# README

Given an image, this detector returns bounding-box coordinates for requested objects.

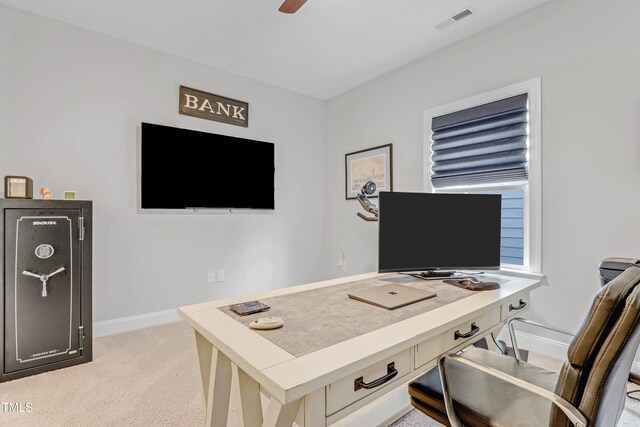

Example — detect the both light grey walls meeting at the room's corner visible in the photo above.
[0,0,640,338]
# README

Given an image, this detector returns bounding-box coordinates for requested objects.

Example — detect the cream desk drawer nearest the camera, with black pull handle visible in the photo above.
[326,349,411,416]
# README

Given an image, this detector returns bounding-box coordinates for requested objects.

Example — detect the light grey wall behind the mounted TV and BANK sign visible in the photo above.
[0,6,326,321]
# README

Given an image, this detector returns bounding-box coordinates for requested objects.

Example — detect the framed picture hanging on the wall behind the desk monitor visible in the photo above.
[344,144,393,200]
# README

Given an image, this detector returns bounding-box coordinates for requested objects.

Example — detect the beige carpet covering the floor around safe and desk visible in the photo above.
[0,322,640,427]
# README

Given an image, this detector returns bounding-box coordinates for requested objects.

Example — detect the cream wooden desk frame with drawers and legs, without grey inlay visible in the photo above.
[178,273,540,427]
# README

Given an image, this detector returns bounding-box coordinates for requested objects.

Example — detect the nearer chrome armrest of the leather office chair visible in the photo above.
[438,354,587,427]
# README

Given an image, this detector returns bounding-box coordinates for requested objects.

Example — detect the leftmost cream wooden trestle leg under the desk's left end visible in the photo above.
[195,332,232,427]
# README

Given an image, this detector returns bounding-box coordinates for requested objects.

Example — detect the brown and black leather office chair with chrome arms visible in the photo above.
[409,267,640,427]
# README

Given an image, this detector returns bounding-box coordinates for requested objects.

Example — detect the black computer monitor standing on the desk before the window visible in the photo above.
[378,192,502,272]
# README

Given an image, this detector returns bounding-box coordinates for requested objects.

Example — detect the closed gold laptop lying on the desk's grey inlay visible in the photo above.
[348,283,436,310]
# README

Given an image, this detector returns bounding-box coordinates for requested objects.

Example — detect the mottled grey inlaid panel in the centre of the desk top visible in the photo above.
[219,274,511,357]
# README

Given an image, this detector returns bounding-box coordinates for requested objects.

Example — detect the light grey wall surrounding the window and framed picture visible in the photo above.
[326,0,640,330]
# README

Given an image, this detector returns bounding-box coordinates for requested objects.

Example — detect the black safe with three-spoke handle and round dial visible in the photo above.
[0,200,92,382]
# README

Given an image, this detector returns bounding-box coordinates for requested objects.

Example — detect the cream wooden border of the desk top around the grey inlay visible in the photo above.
[178,273,541,401]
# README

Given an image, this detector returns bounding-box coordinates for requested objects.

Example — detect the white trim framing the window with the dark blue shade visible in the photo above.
[422,78,542,273]
